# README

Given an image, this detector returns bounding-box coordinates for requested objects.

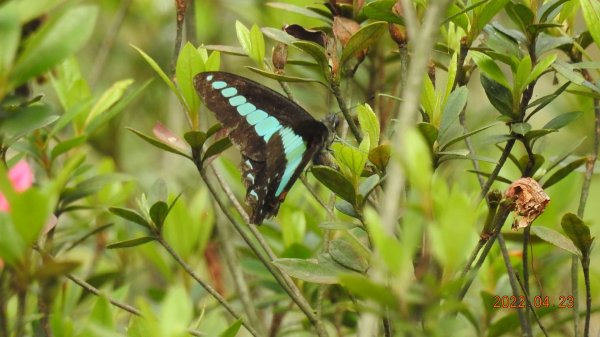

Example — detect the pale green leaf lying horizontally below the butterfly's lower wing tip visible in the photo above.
[273,255,347,284]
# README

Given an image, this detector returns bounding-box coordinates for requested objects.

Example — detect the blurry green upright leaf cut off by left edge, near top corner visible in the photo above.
[0,9,21,80]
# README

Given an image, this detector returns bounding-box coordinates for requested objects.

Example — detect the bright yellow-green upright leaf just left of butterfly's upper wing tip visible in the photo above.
[175,42,205,113]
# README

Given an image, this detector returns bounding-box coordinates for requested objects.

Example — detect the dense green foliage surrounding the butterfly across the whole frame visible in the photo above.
[0,0,600,336]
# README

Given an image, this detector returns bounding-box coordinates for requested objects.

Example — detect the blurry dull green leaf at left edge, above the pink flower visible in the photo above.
[0,104,59,146]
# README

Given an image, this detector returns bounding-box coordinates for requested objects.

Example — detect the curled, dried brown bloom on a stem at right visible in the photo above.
[504,178,550,230]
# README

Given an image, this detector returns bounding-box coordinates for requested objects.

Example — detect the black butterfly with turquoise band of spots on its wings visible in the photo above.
[194,71,329,225]
